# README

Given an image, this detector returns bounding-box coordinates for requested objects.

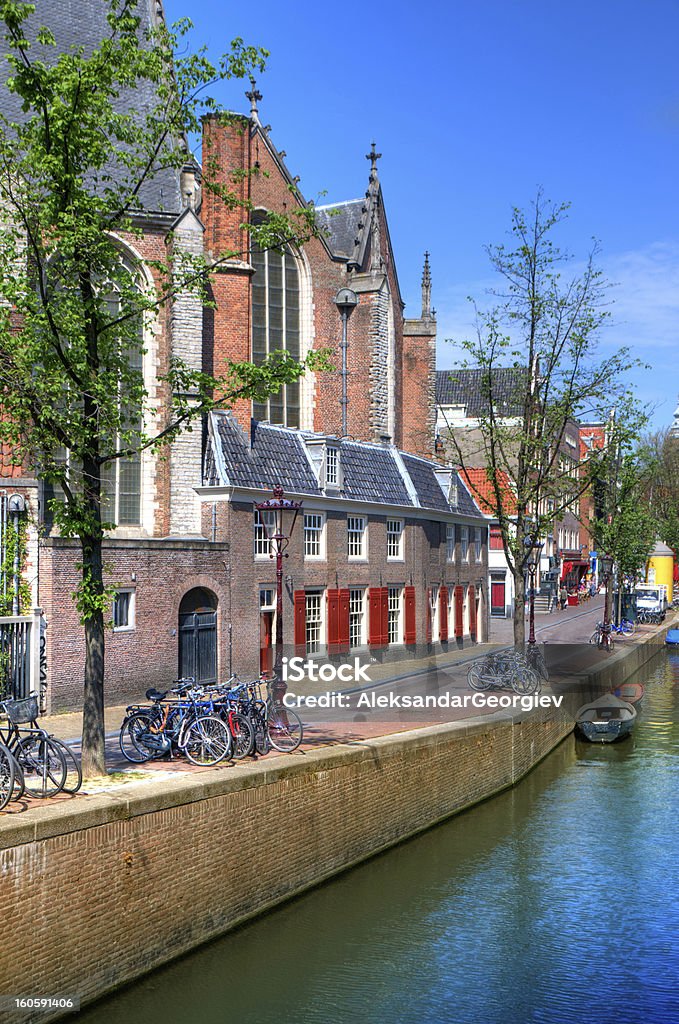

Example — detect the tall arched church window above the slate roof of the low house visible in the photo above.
[251,214,301,427]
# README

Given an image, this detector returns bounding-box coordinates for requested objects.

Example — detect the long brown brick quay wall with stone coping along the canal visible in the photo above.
[0,626,661,1022]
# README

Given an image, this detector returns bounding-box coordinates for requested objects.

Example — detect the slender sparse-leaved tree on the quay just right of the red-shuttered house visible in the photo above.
[451,190,634,644]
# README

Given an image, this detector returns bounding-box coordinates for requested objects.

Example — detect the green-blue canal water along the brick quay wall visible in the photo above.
[79,653,679,1024]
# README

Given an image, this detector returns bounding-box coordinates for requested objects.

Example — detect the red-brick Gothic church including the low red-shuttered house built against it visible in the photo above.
[0,0,489,711]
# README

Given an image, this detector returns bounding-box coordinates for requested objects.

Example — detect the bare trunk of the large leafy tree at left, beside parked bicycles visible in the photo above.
[82,538,107,778]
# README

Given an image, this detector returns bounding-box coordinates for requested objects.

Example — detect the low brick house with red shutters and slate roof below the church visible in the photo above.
[201,413,489,674]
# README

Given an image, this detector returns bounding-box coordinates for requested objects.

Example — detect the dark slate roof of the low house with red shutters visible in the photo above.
[204,413,480,518]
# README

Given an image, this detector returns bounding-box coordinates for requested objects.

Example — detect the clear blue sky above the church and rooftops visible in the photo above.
[165,0,679,427]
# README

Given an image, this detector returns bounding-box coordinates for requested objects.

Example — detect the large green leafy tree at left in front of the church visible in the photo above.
[0,0,323,775]
